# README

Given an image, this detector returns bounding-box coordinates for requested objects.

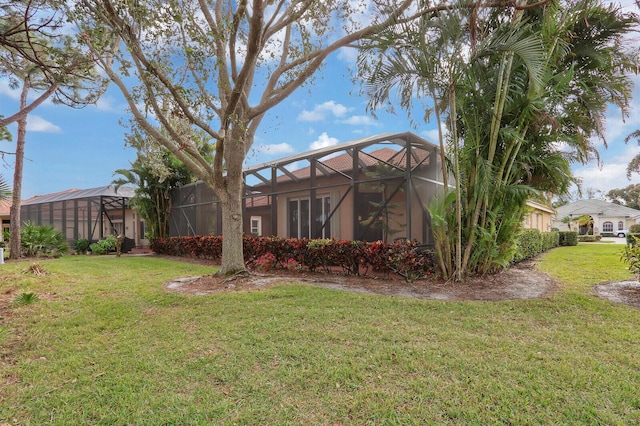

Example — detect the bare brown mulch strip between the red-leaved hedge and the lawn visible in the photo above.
[165,259,556,301]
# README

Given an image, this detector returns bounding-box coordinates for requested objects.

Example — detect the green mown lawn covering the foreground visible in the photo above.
[0,245,640,425]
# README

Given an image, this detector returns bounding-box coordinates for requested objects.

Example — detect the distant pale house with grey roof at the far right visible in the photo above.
[553,199,640,235]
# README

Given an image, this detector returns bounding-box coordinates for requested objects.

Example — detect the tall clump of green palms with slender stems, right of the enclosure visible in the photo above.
[361,0,634,279]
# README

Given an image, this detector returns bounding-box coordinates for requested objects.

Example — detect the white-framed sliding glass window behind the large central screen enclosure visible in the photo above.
[288,196,331,238]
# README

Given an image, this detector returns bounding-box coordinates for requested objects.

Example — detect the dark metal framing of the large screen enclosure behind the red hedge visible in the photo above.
[171,132,444,244]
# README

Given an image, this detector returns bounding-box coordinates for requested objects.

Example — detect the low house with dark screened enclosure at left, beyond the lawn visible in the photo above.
[20,186,147,248]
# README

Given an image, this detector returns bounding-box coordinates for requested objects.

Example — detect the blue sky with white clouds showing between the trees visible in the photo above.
[0,0,640,199]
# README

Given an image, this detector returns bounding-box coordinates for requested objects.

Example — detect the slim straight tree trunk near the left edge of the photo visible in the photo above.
[9,80,29,259]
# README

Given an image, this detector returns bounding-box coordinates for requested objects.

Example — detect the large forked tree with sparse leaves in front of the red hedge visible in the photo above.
[67,0,417,274]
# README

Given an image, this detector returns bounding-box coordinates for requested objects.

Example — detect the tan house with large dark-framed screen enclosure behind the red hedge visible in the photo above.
[170,133,444,244]
